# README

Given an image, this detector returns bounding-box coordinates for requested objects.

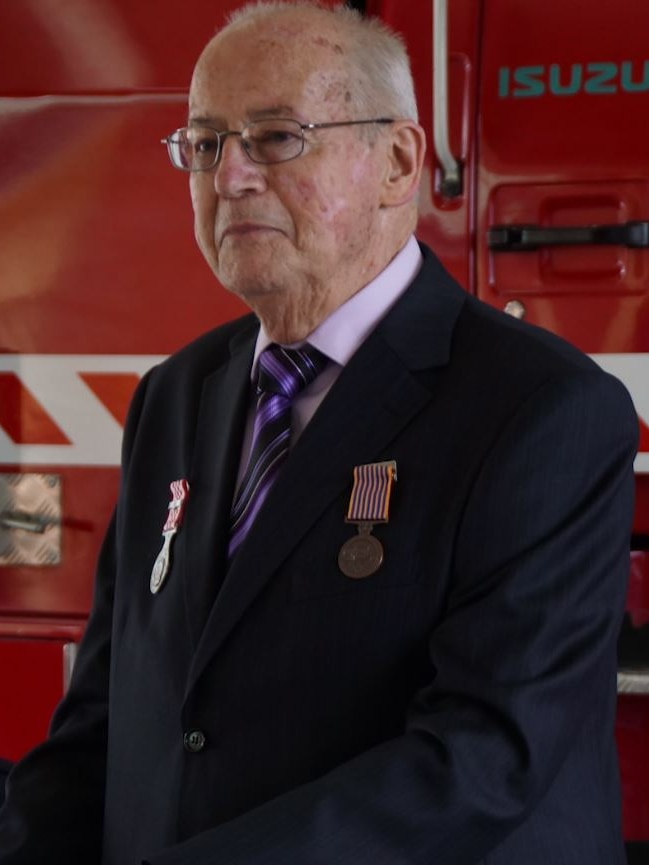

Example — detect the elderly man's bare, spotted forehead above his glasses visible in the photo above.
[190,15,352,120]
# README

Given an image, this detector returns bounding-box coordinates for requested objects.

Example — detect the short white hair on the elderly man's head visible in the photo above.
[219,0,418,121]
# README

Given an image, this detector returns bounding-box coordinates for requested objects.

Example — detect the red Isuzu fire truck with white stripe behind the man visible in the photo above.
[0,0,649,861]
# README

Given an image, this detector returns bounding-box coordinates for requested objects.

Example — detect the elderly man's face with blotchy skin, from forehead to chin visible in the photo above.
[189,15,385,335]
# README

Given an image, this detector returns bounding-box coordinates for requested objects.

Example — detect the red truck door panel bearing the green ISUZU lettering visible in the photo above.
[478,0,649,352]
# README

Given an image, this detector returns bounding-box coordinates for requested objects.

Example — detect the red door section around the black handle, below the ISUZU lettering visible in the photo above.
[481,178,649,353]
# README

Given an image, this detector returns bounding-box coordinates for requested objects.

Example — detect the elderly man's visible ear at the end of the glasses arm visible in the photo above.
[381,120,426,207]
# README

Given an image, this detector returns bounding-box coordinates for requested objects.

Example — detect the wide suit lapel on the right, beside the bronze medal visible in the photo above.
[188,245,466,690]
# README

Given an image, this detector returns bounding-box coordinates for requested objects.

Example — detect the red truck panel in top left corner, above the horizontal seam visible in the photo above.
[0,0,344,96]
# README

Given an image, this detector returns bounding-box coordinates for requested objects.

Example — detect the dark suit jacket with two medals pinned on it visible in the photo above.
[0,245,637,865]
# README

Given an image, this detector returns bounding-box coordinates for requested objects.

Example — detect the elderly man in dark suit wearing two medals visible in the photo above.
[0,3,637,865]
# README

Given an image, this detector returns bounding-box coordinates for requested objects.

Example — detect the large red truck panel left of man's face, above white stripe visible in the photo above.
[0,97,243,354]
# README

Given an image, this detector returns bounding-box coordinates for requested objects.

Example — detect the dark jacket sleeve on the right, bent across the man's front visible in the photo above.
[147,368,638,865]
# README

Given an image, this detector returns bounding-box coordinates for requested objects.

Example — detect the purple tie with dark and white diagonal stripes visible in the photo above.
[228,345,328,558]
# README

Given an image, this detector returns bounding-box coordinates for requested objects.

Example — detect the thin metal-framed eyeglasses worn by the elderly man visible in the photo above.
[161,117,394,171]
